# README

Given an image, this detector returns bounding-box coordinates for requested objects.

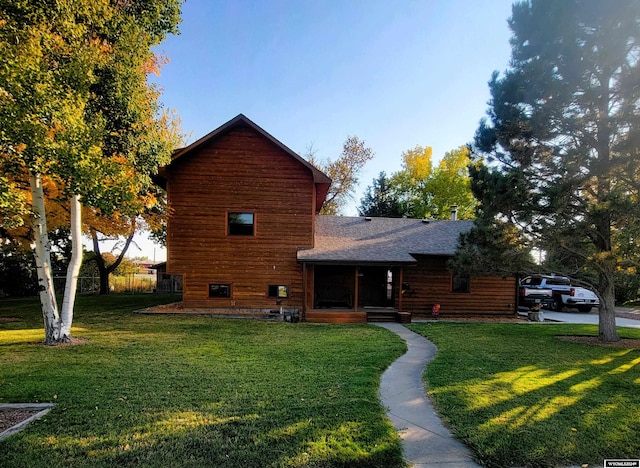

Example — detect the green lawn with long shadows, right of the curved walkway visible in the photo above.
[410,323,640,467]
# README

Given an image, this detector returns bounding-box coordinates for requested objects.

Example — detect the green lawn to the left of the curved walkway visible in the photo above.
[0,294,405,468]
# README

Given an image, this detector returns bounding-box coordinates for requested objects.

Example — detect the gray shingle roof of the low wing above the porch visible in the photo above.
[298,216,473,263]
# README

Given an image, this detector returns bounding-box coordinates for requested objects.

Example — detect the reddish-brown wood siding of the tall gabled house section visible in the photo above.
[167,122,315,310]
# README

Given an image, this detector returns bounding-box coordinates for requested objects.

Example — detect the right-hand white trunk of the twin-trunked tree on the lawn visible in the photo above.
[59,195,82,341]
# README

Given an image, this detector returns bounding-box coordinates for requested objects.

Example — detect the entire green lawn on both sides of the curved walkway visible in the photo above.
[6,294,640,468]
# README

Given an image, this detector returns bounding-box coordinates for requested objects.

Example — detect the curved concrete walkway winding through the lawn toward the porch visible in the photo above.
[376,323,480,468]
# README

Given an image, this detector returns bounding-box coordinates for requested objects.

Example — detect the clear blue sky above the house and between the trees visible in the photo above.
[136,0,512,255]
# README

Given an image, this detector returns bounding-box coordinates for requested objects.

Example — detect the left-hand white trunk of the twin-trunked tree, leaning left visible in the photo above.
[29,172,60,344]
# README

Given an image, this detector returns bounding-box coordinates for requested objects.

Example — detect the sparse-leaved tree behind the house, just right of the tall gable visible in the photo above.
[306,136,374,215]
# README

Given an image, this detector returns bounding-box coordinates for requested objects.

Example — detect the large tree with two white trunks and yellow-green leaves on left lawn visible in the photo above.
[0,0,181,344]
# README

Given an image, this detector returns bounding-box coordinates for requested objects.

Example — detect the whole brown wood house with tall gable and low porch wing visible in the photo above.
[156,115,516,322]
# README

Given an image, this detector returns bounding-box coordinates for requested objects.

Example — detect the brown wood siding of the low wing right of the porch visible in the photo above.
[402,256,516,319]
